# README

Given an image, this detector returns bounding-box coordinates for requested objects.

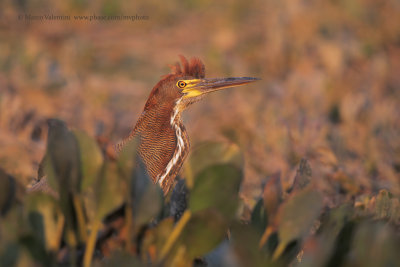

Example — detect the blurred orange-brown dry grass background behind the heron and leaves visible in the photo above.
[0,0,400,201]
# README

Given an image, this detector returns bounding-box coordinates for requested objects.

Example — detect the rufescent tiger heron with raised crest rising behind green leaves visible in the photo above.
[116,56,259,194]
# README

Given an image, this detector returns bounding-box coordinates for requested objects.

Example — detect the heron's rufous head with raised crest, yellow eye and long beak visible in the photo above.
[145,56,259,112]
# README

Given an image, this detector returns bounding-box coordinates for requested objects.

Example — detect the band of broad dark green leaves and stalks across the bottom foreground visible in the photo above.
[0,120,400,266]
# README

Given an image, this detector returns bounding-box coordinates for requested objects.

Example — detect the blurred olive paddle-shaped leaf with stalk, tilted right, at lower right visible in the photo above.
[273,188,323,259]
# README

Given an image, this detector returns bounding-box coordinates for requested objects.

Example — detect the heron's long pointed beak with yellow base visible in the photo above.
[178,77,260,98]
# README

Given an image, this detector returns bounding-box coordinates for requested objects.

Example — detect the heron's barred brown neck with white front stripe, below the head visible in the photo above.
[117,103,190,192]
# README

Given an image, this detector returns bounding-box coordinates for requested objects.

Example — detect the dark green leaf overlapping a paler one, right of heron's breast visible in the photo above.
[189,164,243,220]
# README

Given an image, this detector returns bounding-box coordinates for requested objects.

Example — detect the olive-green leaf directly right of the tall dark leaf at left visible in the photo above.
[72,130,103,191]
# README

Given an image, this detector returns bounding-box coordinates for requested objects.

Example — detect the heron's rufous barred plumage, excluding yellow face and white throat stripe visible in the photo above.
[116,55,205,193]
